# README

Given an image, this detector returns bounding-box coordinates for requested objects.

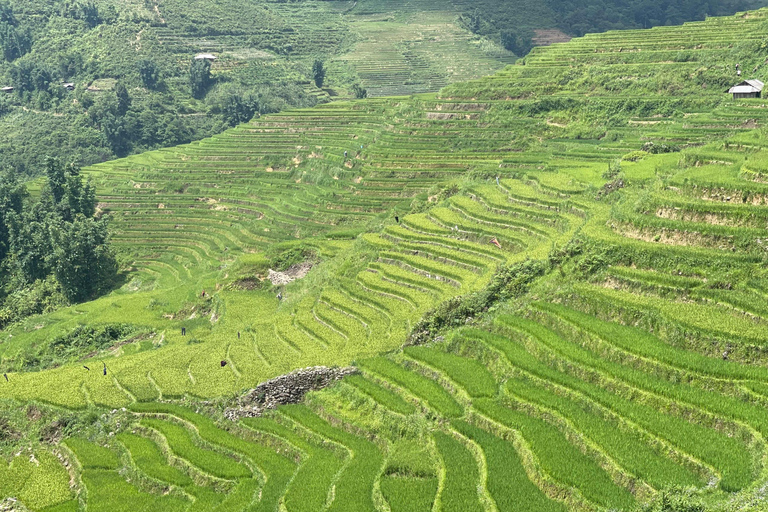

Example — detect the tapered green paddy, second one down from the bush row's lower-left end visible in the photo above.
[359,357,463,417]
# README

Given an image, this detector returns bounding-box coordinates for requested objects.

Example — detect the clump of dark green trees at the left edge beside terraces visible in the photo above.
[0,158,117,327]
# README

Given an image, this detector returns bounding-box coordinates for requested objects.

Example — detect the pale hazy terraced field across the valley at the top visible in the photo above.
[144,0,516,99]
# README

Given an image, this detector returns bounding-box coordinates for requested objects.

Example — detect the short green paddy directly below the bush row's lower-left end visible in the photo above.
[404,347,497,398]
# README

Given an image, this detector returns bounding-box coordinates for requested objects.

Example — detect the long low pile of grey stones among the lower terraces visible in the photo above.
[224,366,358,421]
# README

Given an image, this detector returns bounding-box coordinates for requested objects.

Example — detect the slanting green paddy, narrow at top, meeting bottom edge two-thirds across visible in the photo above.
[451,420,566,512]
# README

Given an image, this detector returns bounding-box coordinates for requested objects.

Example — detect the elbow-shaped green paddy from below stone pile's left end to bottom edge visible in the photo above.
[242,418,344,512]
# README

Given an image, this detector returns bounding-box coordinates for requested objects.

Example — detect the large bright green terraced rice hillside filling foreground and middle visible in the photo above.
[6,11,768,512]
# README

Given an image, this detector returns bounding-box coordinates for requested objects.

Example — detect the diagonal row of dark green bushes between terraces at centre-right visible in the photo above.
[408,260,550,345]
